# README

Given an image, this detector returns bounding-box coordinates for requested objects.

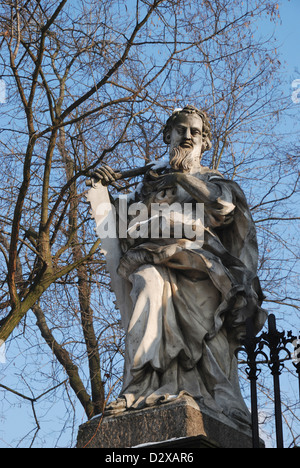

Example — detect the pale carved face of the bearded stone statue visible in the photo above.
[170,113,203,155]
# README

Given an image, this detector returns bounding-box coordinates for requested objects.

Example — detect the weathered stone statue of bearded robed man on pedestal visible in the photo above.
[88,106,266,425]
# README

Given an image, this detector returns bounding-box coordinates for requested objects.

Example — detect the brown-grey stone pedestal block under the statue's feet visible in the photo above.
[77,397,258,448]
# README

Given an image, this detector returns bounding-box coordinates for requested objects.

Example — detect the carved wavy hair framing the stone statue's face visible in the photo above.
[163,106,212,153]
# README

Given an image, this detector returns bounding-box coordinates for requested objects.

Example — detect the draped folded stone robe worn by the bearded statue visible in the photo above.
[88,167,266,424]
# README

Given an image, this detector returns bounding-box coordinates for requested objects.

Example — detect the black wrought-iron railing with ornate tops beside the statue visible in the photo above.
[238,314,300,448]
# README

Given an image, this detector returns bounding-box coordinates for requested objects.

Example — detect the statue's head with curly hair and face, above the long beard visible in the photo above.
[163,106,212,159]
